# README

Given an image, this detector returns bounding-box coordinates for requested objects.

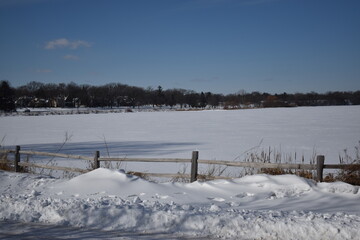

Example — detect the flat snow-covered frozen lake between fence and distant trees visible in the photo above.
[0,106,360,173]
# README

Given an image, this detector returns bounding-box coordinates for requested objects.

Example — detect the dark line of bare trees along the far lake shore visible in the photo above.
[0,81,360,111]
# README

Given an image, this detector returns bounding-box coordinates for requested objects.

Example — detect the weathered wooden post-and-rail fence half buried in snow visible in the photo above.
[0,146,360,182]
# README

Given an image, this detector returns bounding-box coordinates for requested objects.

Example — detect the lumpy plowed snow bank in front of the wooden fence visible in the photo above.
[0,169,360,239]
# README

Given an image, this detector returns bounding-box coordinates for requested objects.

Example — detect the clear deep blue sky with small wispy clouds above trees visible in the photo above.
[0,0,360,94]
